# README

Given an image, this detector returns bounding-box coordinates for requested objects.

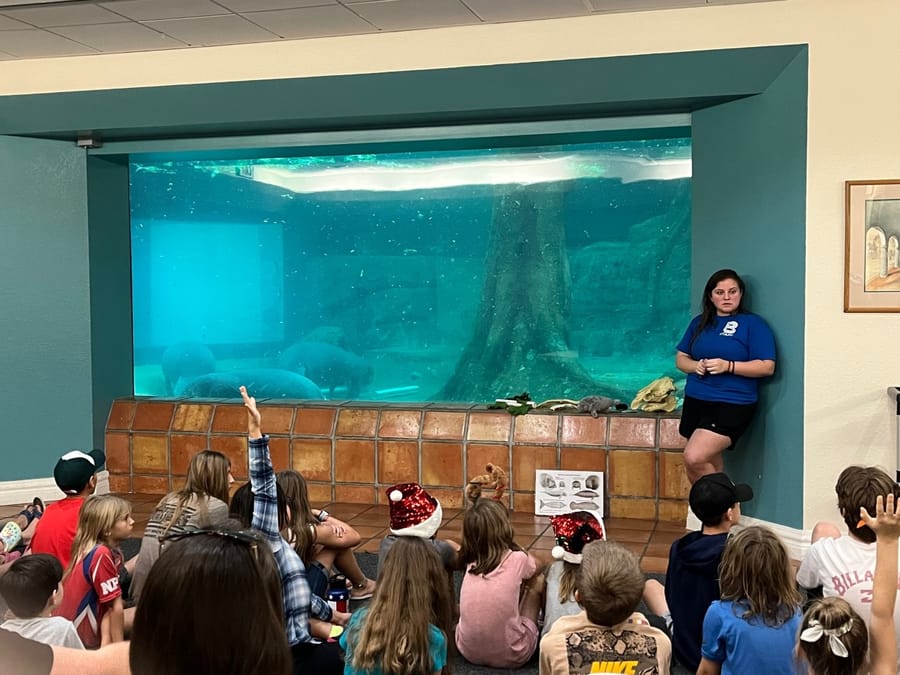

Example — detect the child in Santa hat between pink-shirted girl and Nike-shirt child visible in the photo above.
[541,511,606,636]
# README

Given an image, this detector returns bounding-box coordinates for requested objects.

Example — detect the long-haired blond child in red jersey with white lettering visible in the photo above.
[56,495,134,649]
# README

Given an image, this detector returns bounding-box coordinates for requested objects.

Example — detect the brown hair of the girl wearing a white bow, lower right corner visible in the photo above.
[797,598,869,675]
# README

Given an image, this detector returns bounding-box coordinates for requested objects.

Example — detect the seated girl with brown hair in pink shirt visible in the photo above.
[456,499,544,668]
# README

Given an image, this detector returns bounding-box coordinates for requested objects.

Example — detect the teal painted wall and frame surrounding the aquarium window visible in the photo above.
[0,7,828,527]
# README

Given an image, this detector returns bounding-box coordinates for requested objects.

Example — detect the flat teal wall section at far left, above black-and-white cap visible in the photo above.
[0,137,94,481]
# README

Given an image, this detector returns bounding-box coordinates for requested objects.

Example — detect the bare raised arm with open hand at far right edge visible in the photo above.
[860,495,900,675]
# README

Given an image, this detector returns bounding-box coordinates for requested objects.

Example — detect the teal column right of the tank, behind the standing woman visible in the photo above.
[692,48,808,528]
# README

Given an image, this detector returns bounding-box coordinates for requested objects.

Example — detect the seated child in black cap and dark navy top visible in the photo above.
[644,473,753,672]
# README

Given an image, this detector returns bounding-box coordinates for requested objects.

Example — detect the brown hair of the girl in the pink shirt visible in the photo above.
[459,499,522,574]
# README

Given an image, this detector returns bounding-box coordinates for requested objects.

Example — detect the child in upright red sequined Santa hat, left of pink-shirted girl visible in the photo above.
[378,483,459,574]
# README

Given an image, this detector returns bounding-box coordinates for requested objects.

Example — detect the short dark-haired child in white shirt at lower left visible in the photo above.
[0,553,84,649]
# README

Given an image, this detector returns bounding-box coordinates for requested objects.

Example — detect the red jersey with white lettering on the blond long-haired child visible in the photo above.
[54,544,122,649]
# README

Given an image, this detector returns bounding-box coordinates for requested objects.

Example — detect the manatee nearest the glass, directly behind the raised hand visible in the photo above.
[175,368,323,400]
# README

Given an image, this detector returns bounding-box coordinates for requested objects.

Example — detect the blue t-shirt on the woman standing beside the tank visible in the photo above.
[676,314,775,403]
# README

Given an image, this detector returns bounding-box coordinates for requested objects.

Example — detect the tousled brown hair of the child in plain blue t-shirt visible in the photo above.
[719,526,800,626]
